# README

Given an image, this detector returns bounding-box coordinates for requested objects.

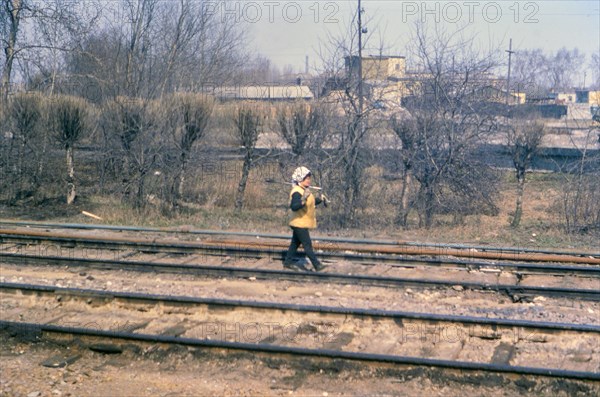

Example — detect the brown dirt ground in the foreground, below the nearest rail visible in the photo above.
[0,332,600,397]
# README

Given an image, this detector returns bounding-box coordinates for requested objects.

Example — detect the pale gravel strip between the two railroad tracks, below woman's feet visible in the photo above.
[0,264,600,325]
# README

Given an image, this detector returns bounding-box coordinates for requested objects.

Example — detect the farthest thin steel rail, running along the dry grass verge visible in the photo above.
[0,220,600,257]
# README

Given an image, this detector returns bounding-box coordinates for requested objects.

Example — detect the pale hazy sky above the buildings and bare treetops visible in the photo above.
[229,0,600,78]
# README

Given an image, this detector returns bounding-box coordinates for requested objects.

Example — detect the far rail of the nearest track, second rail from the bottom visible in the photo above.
[0,283,600,333]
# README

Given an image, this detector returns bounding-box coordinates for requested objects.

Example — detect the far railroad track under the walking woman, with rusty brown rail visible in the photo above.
[0,226,600,300]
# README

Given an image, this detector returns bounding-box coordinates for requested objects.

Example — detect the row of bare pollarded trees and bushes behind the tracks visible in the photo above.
[0,93,600,233]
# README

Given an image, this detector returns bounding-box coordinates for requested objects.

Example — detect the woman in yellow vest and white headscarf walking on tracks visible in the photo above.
[283,167,327,272]
